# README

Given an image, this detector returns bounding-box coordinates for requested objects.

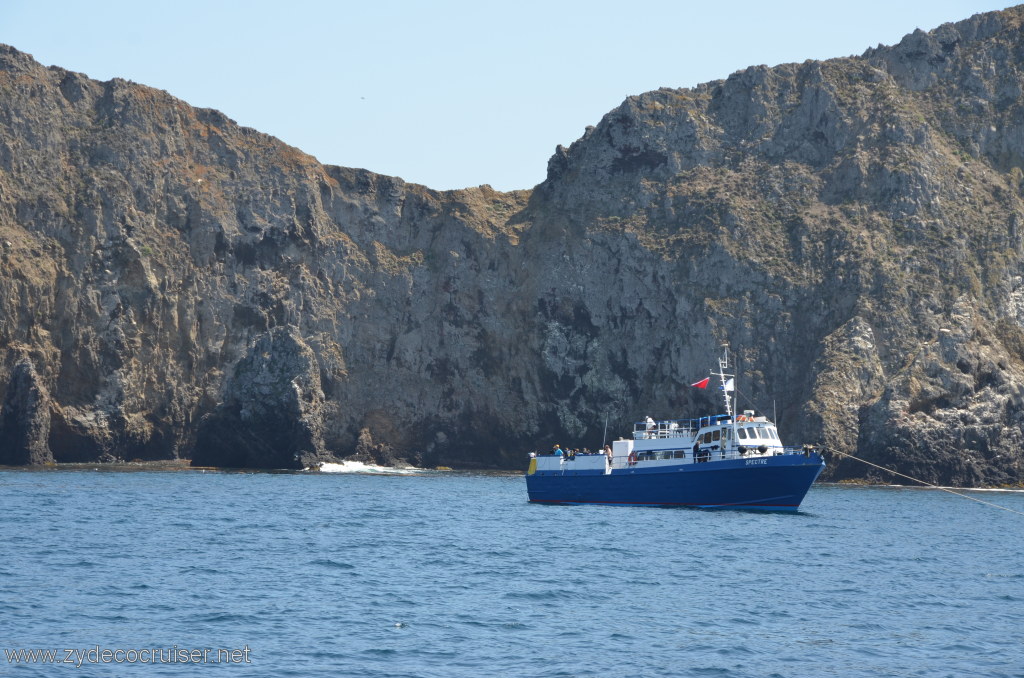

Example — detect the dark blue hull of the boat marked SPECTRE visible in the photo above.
[526,454,824,511]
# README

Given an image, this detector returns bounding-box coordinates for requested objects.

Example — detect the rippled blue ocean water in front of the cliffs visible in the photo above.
[0,470,1024,678]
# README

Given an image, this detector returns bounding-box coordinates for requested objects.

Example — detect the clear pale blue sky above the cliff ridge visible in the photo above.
[0,0,1007,190]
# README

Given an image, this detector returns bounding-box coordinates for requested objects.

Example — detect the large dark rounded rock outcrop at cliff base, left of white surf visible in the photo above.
[193,325,331,468]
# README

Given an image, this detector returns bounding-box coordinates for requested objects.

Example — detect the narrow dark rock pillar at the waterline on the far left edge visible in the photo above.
[0,357,53,466]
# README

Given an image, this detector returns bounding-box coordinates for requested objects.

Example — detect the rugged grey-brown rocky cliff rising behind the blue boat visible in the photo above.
[0,3,1024,485]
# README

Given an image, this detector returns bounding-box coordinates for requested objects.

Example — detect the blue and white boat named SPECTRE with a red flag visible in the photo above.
[526,349,825,511]
